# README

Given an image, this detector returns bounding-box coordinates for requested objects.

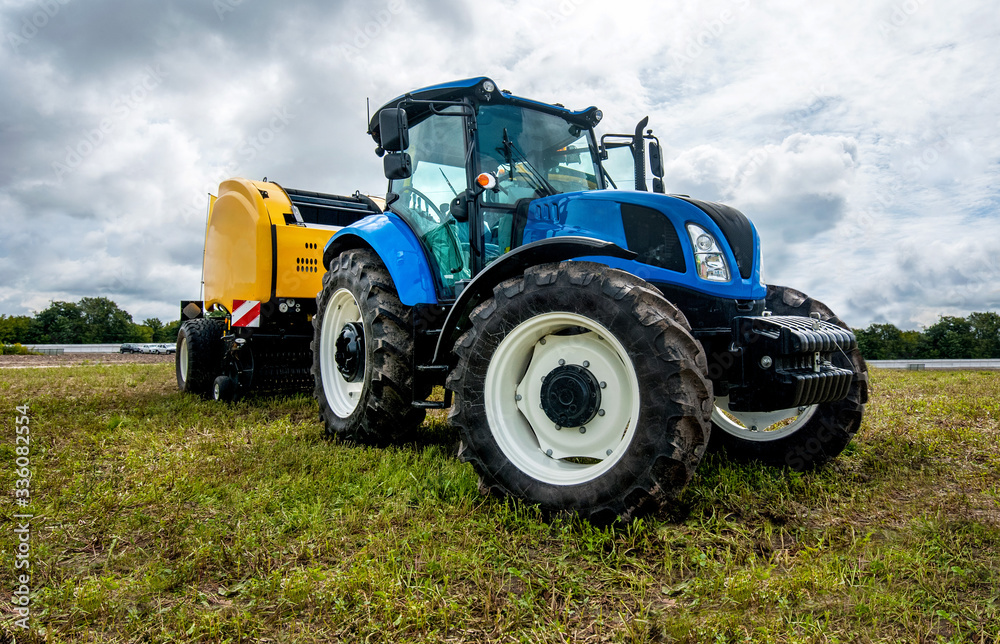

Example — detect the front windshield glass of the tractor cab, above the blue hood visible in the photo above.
[476,104,600,205]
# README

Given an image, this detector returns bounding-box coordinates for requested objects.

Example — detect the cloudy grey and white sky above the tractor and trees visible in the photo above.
[0,0,1000,328]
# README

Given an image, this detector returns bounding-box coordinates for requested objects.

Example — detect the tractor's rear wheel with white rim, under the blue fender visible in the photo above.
[312,249,430,444]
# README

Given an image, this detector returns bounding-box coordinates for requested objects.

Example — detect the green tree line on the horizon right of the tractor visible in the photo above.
[854,313,1000,360]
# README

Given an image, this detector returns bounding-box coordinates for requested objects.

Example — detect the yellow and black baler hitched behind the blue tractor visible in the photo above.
[177,178,382,398]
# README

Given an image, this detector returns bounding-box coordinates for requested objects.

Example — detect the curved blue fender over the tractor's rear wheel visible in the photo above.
[323,212,438,306]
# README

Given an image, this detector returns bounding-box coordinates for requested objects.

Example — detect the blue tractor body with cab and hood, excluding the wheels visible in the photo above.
[324,77,850,418]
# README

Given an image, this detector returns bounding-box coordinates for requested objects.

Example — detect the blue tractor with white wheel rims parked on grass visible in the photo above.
[312,78,867,523]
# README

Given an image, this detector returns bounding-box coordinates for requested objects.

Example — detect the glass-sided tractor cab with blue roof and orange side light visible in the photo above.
[371,78,606,300]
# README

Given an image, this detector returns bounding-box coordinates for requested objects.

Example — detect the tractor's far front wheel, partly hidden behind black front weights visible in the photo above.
[711,286,868,471]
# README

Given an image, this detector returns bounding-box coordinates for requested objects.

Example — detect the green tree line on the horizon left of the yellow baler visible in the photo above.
[0,297,181,344]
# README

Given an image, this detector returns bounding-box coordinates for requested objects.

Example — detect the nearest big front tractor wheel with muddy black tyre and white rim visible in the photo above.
[448,262,712,523]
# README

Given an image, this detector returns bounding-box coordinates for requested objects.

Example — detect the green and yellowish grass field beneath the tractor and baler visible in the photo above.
[0,365,1000,642]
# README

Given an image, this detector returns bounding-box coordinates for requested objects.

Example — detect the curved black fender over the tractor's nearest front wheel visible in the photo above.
[434,237,636,364]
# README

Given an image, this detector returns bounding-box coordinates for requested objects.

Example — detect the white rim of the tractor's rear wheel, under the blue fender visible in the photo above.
[319,288,367,418]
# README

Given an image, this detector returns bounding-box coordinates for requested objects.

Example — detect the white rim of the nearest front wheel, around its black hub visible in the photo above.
[484,313,640,485]
